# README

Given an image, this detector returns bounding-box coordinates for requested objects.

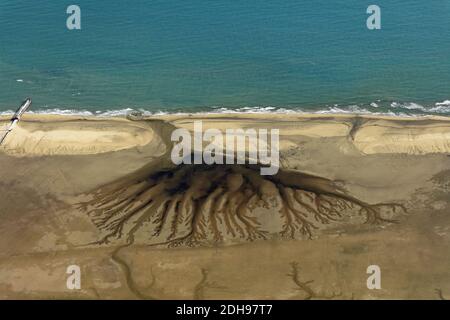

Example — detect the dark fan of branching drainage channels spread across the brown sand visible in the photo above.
[76,165,406,246]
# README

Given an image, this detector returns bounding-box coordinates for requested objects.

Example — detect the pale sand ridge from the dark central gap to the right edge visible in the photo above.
[157,114,450,154]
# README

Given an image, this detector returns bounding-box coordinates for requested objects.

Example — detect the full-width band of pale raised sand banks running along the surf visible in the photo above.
[0,114,450,156]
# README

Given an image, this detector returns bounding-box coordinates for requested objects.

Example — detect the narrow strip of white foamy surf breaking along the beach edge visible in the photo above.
[0,99,450,117]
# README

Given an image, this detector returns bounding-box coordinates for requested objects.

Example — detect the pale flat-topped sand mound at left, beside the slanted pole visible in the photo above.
[0,116,153,156]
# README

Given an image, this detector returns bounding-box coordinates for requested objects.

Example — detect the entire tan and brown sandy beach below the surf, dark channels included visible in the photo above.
[0,113,450,299]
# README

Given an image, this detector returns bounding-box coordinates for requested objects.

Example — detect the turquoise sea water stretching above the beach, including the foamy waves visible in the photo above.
[0,0,450,115]
